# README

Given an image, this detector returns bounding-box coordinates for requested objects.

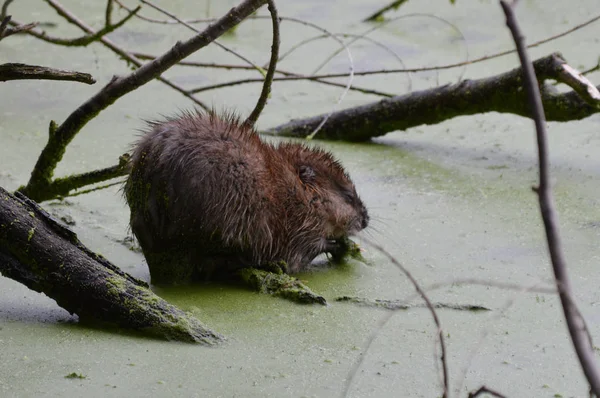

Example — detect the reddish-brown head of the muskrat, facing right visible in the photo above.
[279,144,369,240]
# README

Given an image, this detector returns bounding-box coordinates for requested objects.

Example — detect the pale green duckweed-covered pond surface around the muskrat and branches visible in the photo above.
[0,0,600,397]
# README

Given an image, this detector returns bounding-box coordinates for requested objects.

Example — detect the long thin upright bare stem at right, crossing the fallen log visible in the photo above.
[500,0,600,396]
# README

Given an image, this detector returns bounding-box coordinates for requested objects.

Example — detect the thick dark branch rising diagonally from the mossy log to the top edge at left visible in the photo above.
[20,0,266,201]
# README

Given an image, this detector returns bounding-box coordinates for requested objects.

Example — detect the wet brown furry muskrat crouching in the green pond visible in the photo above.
[125,111,369,283]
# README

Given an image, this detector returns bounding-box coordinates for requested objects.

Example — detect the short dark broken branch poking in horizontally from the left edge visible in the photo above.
[0,64,96,84]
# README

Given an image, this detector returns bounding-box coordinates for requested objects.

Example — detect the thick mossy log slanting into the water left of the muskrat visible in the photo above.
[0,187,222,345]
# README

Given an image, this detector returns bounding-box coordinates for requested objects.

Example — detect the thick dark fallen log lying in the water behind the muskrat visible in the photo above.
[263,53,600,141]
